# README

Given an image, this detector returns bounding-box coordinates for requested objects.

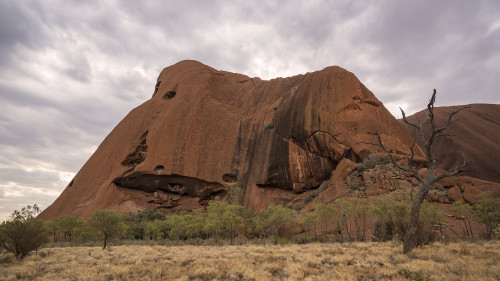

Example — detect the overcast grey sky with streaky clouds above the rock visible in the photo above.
[0,0,500,221]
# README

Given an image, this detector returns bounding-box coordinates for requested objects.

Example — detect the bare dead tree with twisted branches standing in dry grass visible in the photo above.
[365,89,468,254]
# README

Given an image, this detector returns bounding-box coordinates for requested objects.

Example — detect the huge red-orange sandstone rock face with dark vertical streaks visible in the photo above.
[40,61,422,219]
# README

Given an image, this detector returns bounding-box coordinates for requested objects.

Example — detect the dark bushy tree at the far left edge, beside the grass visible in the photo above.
[0,204,46,260]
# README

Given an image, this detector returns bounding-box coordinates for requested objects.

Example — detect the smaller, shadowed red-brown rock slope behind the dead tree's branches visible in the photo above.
[399,104,500,183]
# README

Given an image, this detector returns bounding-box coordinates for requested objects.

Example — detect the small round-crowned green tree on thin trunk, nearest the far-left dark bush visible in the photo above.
[89,210,127,250]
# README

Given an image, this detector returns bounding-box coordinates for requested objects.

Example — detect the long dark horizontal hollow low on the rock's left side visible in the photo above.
[113,173,227,201]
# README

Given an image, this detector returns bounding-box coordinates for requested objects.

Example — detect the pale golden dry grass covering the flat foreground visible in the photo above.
[0,241,500,280]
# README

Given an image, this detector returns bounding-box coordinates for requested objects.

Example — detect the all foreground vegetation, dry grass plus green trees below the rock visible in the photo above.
[0,186,500,280]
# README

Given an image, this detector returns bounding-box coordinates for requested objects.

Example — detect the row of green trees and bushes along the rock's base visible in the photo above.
[0,191,500,260]
